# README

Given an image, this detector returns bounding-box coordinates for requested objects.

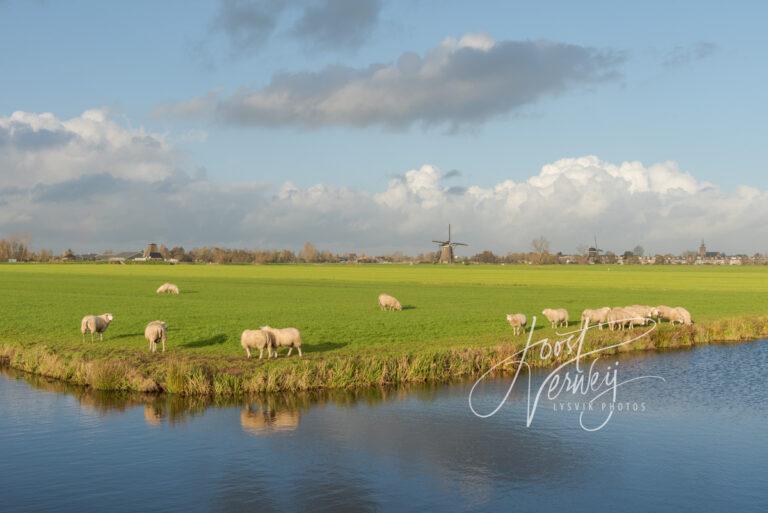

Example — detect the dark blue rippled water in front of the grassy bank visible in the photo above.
[0,342,768,512]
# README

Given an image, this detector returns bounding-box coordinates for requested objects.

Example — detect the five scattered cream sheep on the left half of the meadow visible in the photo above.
[80,283,304,359]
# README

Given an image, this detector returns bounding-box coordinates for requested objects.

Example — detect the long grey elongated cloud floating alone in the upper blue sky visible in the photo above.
[157,34,623,128]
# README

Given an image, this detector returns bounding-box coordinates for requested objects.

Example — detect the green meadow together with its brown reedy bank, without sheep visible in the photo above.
[0,264,768,394]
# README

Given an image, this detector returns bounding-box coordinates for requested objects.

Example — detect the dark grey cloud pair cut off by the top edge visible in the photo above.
[212,0,381,53]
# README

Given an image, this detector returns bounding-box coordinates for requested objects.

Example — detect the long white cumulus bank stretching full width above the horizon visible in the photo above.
[0,113,768,253]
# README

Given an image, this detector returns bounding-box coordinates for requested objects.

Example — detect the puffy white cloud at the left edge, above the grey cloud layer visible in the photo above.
[0,110,178,188]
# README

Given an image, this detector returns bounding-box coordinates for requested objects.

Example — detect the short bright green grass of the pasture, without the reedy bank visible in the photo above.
[0,264,768,392]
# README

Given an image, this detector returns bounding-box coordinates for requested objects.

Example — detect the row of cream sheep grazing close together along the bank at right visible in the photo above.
[507,305,693,335]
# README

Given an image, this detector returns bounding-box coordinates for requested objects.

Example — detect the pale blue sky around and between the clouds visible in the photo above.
[0,0,768,253]
